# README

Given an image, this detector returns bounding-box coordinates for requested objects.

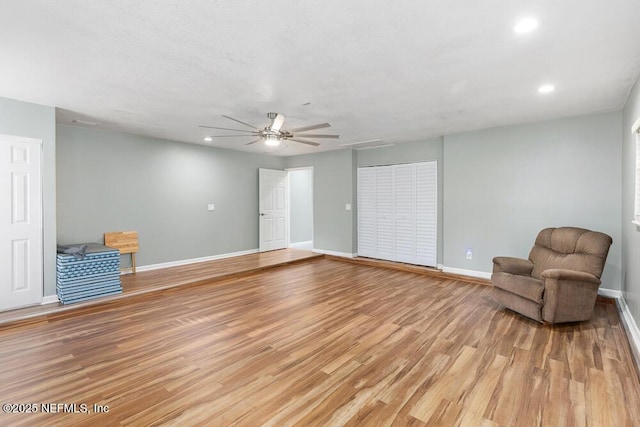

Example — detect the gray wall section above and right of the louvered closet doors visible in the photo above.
[354,138,444,264]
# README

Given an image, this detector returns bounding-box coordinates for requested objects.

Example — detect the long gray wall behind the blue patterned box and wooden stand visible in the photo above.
[57,125,283,266]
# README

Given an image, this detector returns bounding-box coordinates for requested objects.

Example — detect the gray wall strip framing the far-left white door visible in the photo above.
[0,98,56,296]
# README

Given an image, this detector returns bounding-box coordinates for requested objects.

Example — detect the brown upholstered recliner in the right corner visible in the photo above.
[491,227,612,323]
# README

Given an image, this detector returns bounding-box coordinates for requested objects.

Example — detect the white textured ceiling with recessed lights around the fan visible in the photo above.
[0,0,640,155]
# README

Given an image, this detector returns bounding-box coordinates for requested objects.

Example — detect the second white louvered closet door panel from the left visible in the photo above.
[375,166,396,260]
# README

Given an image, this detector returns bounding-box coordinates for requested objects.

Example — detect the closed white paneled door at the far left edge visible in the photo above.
[0,135,43,310]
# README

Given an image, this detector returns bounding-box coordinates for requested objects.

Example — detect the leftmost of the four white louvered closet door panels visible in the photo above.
[358,168,378,258]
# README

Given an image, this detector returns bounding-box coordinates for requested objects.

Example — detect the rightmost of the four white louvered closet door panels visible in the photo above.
[416,162,438,267]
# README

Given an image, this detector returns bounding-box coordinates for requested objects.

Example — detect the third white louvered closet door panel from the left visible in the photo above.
[393,164,418,264]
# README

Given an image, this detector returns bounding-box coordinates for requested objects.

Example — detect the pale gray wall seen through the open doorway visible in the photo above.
[289,169,313,243]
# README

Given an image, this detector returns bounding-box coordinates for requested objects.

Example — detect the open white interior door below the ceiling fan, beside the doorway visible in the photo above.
[258,169,289,252]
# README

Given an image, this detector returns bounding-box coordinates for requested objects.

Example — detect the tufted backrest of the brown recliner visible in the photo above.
[529,227,612,279]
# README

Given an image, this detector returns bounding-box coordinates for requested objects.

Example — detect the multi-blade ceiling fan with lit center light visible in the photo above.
[200,113,340,147]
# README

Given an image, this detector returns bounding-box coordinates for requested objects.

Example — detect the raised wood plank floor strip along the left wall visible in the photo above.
[0,248,324,325]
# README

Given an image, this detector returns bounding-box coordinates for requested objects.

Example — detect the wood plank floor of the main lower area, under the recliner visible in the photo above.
[0,259,640,426]
